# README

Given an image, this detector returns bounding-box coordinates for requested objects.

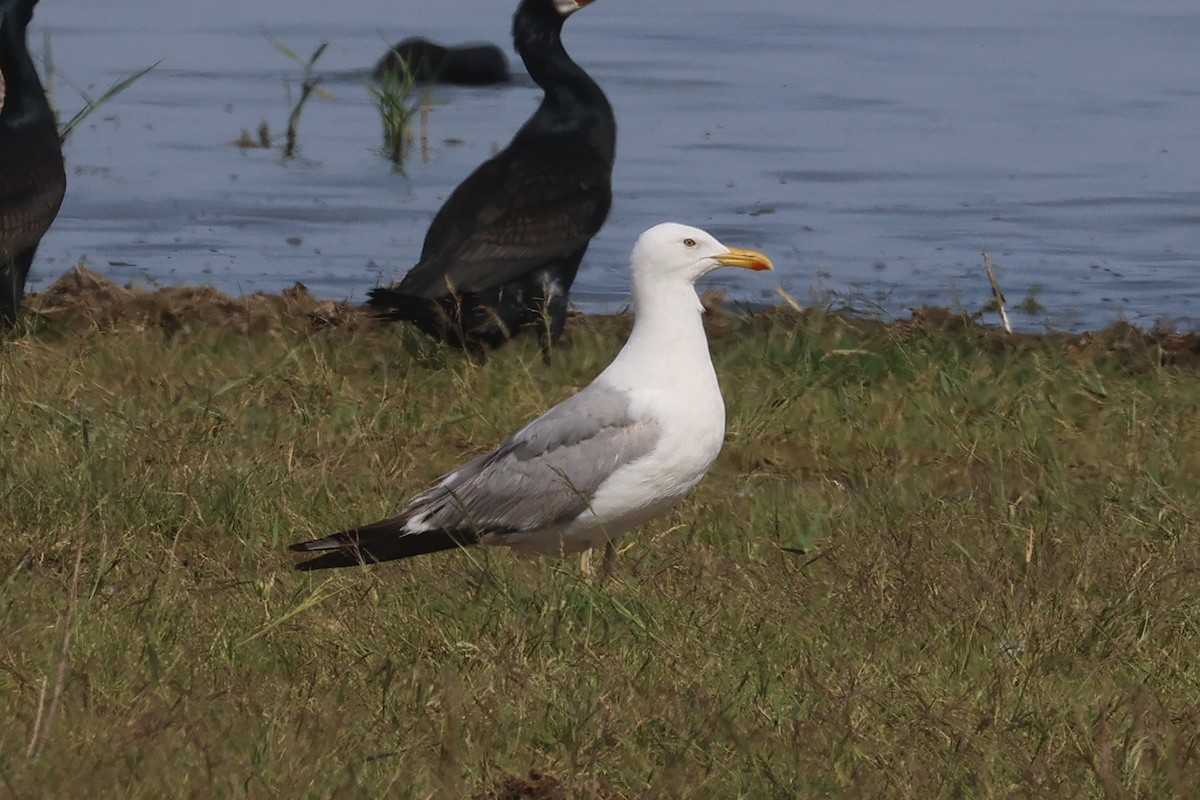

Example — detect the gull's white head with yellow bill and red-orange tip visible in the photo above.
[630,222,774,284]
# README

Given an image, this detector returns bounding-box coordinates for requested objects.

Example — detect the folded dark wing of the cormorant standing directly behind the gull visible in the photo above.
[395,136,612,299]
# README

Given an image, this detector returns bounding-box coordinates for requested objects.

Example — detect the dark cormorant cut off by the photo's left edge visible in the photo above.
[0,0,67,327]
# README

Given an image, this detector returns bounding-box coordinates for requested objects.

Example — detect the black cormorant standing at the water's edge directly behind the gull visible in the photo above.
[367,0,617,353]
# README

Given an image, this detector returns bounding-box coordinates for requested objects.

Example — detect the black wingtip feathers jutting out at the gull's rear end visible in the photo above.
[288,517,479,571]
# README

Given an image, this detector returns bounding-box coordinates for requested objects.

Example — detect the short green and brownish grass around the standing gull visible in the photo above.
[0,313,1200,799]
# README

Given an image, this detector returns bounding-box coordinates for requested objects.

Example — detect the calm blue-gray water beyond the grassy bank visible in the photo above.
[30,0,1200,329]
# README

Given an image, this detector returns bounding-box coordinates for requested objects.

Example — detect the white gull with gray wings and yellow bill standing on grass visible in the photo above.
[290,222,772,570]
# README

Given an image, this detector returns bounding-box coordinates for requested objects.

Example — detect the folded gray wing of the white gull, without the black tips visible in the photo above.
[403,384,660,536]
